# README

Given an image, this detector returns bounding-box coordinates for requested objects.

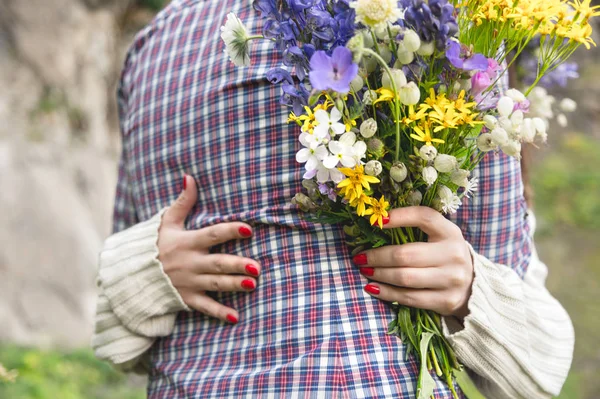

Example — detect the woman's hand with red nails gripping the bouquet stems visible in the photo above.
[354,206,473,319]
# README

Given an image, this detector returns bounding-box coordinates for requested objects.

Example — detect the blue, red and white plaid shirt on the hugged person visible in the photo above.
[114,0,530,398]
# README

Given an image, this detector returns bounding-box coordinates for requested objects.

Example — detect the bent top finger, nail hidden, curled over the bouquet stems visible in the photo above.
[384,206,462,238]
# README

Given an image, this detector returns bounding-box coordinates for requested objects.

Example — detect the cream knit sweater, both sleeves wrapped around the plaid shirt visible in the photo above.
[92,209,575,399]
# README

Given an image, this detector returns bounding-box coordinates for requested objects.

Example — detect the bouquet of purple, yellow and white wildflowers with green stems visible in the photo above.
[221,0,600,398]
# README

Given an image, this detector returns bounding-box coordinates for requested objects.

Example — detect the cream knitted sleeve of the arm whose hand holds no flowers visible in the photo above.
[92,208,189,372]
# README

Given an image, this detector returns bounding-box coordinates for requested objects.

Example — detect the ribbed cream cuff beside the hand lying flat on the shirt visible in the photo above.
[98,208,189,337]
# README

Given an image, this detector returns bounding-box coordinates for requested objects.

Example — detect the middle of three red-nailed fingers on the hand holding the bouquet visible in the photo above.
[360,267,450,289]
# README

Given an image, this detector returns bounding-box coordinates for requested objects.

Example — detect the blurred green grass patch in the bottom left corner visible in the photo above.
[0,345,146,399]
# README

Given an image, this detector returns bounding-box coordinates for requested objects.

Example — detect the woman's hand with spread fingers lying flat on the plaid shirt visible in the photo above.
[158,175,260,324]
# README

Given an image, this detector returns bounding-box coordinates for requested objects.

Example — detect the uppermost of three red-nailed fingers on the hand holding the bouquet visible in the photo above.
[352,242,447,267]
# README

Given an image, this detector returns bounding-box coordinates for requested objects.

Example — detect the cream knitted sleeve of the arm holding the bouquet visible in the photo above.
[443,242,575,399]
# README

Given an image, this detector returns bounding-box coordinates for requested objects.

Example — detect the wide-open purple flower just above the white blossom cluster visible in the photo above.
[308,47,358,93]
